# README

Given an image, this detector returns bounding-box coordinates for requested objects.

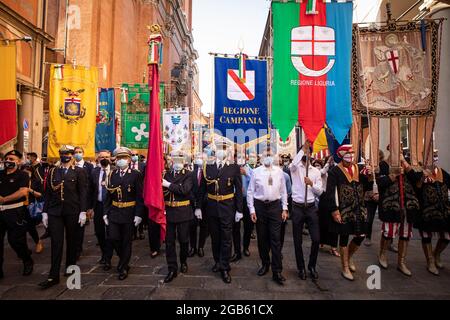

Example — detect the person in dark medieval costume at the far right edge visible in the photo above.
[414,150,450,276]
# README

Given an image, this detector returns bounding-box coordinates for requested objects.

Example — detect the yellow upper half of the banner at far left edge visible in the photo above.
[0,42,16,100]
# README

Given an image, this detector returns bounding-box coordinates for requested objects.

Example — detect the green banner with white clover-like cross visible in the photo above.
[121,84,150,149]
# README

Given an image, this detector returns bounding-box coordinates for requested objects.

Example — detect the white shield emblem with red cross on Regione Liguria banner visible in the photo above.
[291,26,336,77]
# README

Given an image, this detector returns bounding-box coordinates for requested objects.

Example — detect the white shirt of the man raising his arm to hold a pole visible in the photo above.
[289,150,323,204]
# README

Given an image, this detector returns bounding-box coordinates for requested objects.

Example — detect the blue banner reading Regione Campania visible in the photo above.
[214,58,268,144]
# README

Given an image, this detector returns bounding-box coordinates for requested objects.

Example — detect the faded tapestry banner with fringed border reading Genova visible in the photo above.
[352,20,441,118]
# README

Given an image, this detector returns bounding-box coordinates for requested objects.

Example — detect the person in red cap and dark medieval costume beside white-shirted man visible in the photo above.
[325,145,370,281]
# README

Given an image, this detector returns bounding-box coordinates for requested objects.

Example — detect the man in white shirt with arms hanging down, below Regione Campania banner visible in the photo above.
[247,151,288,285]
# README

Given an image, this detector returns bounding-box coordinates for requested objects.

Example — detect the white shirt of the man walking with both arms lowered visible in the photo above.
[247,166,288,213]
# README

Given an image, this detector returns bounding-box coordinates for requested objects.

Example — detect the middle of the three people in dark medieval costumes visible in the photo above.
[377,155,421,276]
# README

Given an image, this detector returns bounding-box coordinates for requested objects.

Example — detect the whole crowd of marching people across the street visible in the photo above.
[0,143,450,289]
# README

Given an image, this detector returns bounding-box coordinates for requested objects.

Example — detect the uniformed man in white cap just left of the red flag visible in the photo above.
[103,147,144,280]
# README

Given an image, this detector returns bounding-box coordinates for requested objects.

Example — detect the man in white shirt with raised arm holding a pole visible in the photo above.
[290,142,323,280]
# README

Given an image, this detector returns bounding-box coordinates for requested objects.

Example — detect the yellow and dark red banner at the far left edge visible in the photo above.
[0,41,17,147]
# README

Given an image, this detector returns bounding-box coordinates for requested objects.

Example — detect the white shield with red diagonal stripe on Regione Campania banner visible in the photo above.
[227,69,255,101]
